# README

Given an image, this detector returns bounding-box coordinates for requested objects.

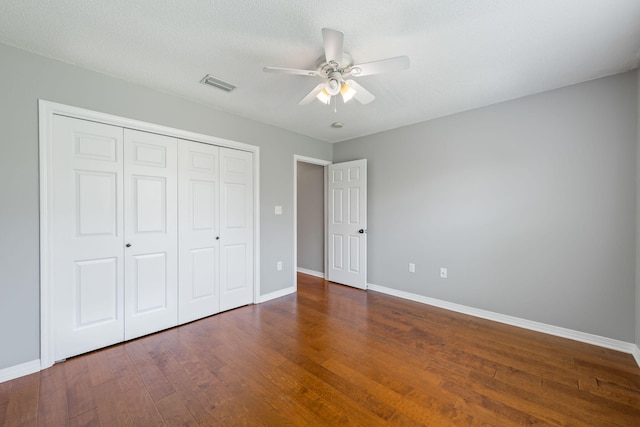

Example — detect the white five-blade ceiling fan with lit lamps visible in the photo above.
[263,28,409,105]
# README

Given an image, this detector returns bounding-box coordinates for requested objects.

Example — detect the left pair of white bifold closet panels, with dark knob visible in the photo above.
[51,116,178,360]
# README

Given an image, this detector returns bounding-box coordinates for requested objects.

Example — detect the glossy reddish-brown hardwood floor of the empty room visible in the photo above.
[0,274,640,427]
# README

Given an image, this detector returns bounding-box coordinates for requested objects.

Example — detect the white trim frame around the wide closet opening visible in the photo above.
[38,99,260,369]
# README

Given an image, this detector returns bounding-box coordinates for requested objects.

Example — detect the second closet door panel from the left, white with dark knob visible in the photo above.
[124,129,178,340]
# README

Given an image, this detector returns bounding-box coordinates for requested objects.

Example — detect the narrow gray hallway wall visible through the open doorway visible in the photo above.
[297,162,324,273]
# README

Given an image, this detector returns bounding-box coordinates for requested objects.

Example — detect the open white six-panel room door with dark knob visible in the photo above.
[327,159,367,289]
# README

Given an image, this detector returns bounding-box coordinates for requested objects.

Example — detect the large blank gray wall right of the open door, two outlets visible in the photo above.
[334,71,638,342]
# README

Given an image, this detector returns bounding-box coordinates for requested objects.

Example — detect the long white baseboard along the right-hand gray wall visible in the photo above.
[368,283,640,367]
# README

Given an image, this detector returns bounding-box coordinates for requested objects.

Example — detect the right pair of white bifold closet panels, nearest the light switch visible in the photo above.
[178,141,253,324]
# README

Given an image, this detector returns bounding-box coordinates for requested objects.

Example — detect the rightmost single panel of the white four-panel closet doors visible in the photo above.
[220,148,253,311]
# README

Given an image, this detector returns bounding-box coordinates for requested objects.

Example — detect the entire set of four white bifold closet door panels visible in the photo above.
[48,116,254,360]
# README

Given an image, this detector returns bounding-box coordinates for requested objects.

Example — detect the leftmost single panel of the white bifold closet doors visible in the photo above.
[49,116,124,360]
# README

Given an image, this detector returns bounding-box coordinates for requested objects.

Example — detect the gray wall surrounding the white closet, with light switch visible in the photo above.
[0,45,332,369]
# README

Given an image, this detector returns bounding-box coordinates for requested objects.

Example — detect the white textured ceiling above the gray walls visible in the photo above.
[0,0,640,142]
